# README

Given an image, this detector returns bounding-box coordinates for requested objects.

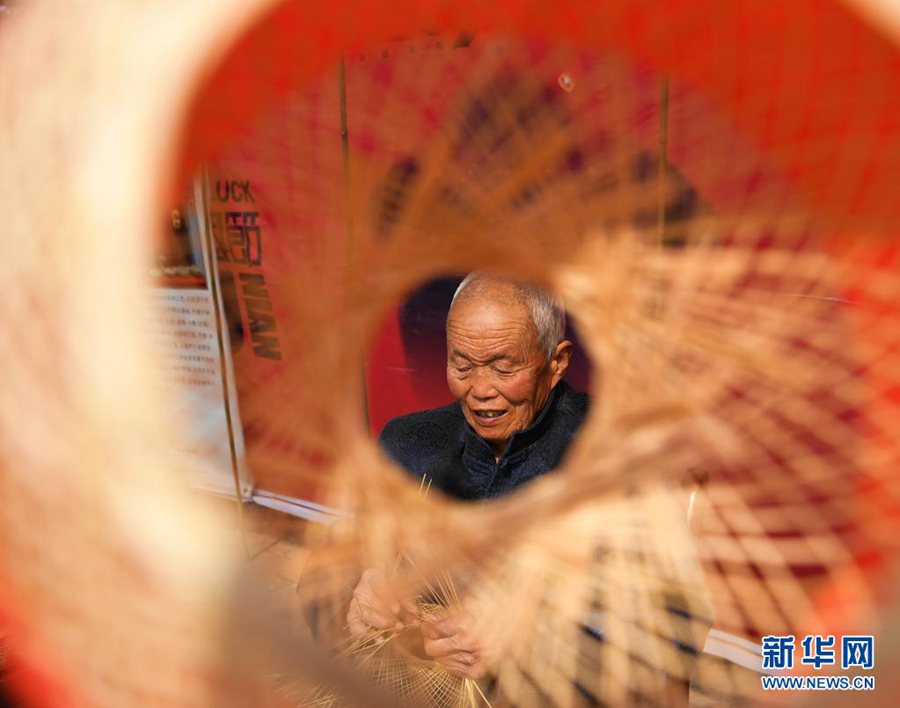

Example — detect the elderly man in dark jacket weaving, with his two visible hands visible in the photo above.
[347,273,588,678]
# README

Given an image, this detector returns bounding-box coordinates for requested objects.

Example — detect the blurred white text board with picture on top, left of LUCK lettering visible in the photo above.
[150,180,253,500]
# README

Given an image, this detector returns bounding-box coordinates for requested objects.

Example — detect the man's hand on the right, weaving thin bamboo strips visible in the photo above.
[421,610,488,680]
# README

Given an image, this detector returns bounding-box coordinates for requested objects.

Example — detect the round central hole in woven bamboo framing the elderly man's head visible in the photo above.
[366,271,591,501]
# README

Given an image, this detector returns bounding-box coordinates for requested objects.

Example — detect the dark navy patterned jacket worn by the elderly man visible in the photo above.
[379,381,588,500]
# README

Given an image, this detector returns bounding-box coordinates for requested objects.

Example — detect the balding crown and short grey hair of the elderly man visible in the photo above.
[448,271,566,359]
